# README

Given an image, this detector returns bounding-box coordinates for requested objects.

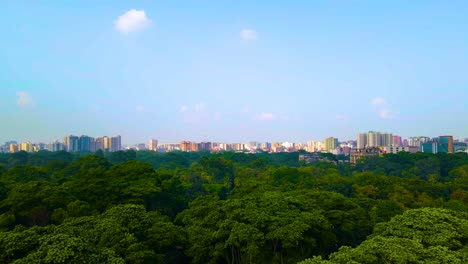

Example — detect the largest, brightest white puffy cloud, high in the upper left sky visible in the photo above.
[115,9,152,34]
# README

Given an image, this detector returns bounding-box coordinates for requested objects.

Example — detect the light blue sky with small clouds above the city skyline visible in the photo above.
[0,0,468,144]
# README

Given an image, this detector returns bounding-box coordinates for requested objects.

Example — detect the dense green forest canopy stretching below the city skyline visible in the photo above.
[0,150,468,264]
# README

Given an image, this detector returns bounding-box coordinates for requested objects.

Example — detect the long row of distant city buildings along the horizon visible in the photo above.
[0,131,468,163]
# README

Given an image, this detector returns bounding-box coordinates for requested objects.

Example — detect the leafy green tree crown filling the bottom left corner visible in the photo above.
[0,205,185,263]
